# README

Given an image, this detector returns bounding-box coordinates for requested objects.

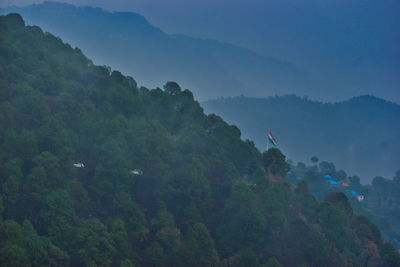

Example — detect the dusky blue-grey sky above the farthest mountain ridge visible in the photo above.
[0,0,400,102]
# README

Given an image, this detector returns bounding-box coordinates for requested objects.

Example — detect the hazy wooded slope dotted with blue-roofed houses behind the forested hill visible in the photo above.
[286,157,400,249]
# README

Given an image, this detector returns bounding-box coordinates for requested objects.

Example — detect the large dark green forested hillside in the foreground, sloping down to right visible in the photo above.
[0,14,400,266]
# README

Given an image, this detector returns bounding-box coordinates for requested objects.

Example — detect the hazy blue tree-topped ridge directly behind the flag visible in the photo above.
[202,96,400,183]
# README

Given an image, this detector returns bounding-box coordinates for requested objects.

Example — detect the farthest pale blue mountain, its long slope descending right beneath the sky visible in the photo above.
[0,2,310,100]
